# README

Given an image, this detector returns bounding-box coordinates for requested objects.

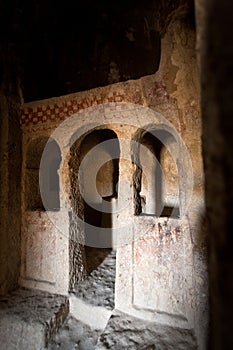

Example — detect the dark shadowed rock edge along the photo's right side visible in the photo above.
[196,0,233,350]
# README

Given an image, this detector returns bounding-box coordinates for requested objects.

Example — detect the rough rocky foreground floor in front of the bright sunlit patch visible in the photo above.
[49,311,198,350]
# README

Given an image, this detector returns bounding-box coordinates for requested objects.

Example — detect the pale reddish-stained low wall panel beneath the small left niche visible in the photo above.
[20,210,69,295]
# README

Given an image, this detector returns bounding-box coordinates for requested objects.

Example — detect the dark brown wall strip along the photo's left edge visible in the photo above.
[0,44,22,294]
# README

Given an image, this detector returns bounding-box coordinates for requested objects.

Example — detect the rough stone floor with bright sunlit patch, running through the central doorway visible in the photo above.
[49,248,197,350]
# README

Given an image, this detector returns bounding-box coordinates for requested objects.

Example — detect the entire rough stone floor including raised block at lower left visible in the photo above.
[0,248,197,350]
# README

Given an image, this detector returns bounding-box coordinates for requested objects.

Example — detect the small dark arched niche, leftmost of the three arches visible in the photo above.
[25,136,61,211]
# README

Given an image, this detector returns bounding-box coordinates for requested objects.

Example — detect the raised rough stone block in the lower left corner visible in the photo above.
[0,289,69,350]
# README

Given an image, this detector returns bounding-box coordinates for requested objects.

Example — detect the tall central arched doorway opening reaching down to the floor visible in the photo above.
[69,129,120,308]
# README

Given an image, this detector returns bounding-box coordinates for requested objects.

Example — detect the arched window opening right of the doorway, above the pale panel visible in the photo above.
[133,128,180,217]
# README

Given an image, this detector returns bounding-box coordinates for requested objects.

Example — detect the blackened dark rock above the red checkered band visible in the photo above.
[0,0,195,101]
